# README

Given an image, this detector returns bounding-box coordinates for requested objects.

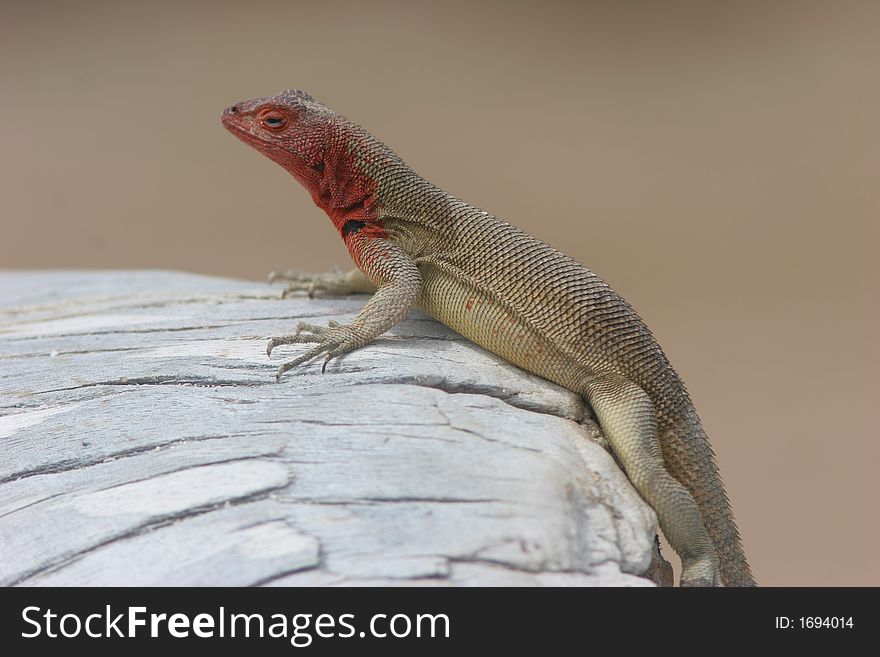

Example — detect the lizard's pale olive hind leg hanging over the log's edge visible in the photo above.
[585,376,721,586]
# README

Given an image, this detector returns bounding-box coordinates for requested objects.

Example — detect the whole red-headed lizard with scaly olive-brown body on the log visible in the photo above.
[221,90,755,586]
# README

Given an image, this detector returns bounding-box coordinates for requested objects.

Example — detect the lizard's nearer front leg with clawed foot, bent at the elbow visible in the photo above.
[266,235,422,380]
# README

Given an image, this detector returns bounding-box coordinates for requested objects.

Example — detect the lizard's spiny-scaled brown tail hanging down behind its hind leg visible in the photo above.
[659,404,757,586]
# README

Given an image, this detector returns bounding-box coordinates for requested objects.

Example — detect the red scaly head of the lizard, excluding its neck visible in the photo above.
[221,89,338,194]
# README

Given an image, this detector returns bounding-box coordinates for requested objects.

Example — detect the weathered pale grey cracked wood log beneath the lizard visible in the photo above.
[0,271,656,585]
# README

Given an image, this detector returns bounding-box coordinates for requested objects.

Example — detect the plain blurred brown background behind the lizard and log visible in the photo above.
[0,0,880,585]
